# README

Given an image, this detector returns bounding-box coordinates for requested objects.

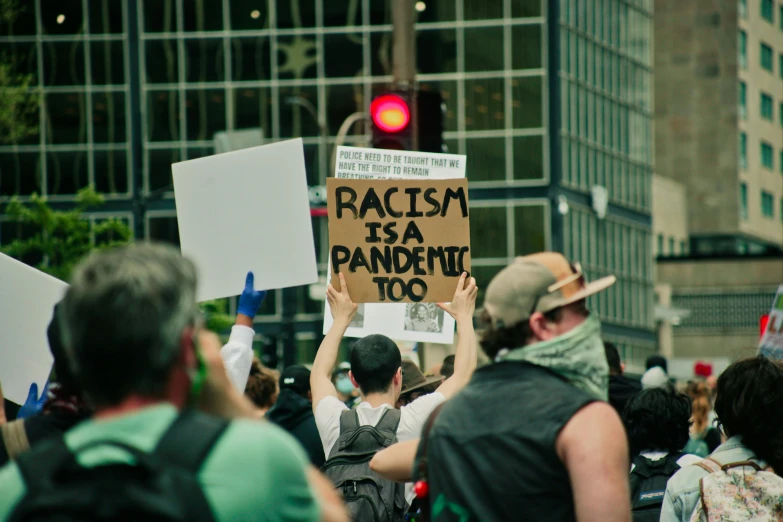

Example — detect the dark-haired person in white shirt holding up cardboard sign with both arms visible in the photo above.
[310,273,478,521]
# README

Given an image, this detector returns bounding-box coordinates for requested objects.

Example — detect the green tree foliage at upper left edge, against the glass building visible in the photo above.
[0,0,41,143]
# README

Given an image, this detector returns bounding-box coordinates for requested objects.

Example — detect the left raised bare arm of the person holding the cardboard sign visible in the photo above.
[310,273,359,411]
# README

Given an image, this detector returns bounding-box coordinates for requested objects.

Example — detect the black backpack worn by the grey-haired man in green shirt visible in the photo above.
[8,410,228,522]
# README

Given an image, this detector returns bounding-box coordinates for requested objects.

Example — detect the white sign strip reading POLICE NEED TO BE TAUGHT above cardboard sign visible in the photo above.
[335,147,465,179]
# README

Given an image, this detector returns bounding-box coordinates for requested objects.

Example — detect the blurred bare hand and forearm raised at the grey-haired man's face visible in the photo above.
[197,330,254,419]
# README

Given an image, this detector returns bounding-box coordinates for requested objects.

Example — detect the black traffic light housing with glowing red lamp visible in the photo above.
[370,91,443,152]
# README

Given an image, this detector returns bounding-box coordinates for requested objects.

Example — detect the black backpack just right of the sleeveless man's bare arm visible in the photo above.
[630,453,684,522]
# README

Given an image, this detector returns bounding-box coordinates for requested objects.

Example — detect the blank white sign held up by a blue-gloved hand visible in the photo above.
[171,139,318,301]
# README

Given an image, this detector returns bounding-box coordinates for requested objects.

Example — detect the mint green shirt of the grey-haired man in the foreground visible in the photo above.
[0,404,320,522]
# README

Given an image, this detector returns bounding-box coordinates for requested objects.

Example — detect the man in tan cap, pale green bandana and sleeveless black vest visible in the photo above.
[414,252,631,522]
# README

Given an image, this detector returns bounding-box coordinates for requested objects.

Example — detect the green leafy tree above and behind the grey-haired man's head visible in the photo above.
[0,187,131,281]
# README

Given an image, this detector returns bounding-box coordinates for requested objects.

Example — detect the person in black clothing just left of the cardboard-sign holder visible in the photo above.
[266,365,326,468]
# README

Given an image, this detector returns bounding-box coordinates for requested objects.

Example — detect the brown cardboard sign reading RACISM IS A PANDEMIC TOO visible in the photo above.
[326,178,470,302]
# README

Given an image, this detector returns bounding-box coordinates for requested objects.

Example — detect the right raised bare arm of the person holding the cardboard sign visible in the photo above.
[438,272,478,399]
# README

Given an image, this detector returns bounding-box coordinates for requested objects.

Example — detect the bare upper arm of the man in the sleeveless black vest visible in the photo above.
[555,402,631,522]
